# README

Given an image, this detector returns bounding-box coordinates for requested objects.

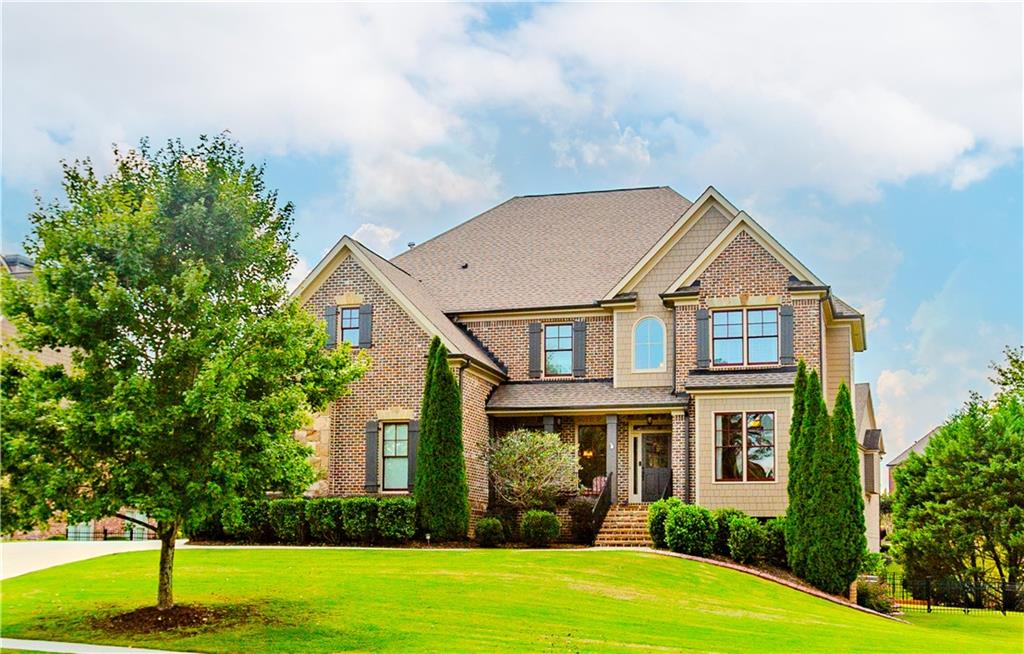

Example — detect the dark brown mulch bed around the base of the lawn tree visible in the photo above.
[92,604,258,635]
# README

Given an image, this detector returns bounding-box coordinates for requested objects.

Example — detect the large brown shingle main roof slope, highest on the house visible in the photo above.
[392,186,690,313]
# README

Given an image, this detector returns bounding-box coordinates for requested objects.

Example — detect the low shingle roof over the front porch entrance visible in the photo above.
[487,380,689,412]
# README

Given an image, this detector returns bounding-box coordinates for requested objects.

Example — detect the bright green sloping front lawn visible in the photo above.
[0,549,1024,654]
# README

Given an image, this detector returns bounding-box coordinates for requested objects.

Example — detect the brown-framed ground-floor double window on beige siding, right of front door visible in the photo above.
[715,411,775,481]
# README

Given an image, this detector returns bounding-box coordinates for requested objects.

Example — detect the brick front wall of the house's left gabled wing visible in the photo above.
[304,257,430,495]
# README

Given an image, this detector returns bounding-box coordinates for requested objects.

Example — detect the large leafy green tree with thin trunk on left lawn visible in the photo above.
[0,136,367,609]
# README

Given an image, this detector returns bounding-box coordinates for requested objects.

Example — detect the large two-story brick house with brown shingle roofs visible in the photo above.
[295,186,881,541]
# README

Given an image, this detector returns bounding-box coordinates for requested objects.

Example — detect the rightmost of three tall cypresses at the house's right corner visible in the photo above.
[805,383,867,594]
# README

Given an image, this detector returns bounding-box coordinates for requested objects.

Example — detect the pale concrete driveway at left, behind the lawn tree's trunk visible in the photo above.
[0,540,184,579]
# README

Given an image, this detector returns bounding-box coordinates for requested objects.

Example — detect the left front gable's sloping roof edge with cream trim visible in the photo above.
[292,235,504,376]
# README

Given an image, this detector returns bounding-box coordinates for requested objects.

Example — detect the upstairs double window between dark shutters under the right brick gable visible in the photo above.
[712,308,778,365]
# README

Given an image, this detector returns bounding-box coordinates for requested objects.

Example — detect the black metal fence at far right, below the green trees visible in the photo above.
[882,574,1024,613]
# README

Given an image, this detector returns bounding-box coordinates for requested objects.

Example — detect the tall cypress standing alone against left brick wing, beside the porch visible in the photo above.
[413,337,469,540]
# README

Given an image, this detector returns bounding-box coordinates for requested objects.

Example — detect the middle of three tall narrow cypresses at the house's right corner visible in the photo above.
[786,369,828,577]
